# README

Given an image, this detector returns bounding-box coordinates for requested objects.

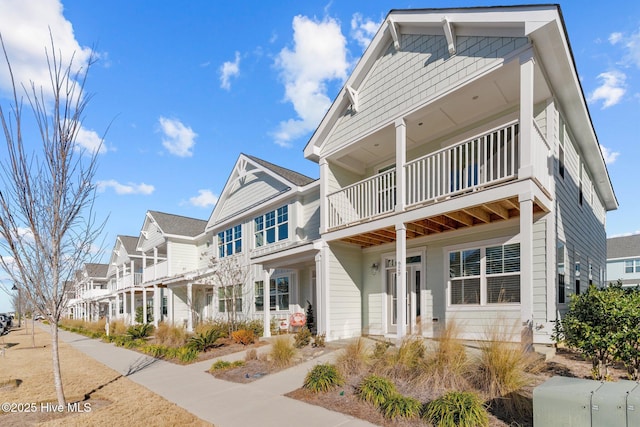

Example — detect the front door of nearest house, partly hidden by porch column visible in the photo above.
[386,257,422,334]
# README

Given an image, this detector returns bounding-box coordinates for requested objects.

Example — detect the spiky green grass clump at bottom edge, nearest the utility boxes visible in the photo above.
[423,391,489,427]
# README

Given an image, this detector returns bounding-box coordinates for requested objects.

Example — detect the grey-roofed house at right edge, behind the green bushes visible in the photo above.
[607,234,640,287]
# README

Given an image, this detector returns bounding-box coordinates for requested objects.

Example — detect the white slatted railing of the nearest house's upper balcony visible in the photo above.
[327,122,550,230]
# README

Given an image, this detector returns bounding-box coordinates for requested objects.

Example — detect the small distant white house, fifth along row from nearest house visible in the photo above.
[68,263,110,322]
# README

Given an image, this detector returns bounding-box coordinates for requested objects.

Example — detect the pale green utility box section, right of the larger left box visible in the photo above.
[585,380,640,427]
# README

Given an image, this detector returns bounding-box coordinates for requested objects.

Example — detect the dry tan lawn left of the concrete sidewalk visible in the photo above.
[0,325,211,426]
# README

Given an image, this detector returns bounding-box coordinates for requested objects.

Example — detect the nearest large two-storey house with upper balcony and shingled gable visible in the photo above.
[304,5,618,343]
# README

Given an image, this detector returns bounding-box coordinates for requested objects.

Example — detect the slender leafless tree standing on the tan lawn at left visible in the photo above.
[0,35,104,405]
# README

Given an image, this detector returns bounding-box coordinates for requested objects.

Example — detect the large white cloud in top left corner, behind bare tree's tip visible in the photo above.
[0,0,92,96]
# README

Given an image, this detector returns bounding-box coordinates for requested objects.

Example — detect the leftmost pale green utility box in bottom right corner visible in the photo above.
[533,377,606,427]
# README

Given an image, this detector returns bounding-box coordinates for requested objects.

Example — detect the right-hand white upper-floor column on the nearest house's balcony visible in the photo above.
[518,49,535,179]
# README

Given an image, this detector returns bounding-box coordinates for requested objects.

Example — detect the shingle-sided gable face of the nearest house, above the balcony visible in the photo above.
[322,34,528,154]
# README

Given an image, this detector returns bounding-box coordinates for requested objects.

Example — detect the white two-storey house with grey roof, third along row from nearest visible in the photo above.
[132,211,211,331]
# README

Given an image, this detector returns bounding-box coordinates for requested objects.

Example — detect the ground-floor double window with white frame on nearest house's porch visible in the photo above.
[449,243,520,305]
